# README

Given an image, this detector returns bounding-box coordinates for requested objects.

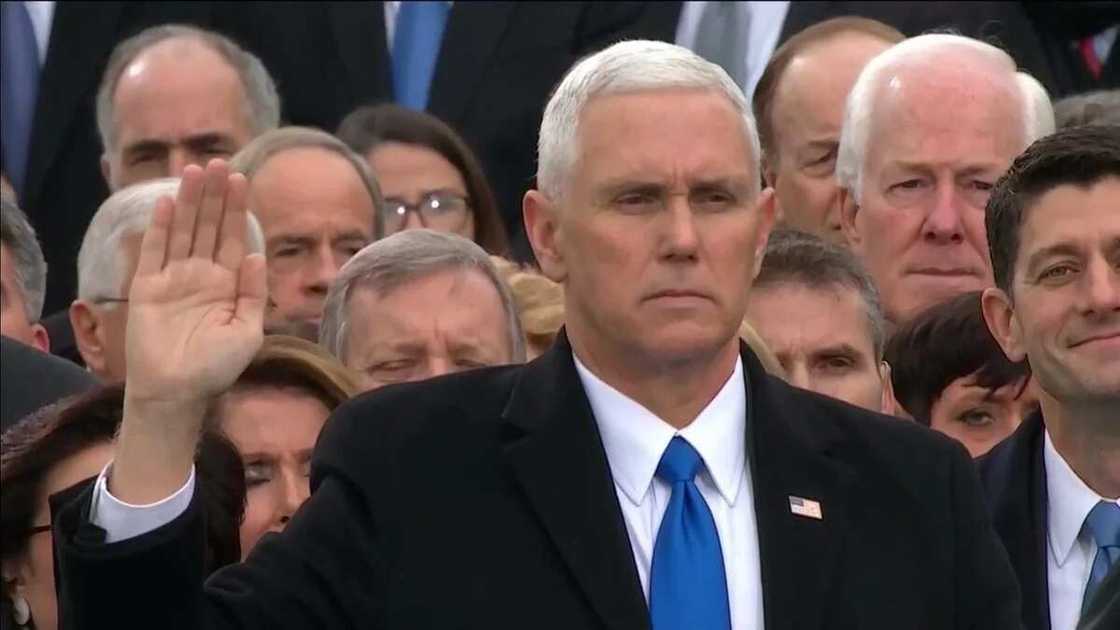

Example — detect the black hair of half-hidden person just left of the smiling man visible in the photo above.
[884,291,1030,426]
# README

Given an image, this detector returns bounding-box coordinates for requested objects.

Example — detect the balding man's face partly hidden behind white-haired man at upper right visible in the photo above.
[766,33,890,243]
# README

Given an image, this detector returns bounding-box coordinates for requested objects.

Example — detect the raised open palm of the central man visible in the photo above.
[125,160,268,402]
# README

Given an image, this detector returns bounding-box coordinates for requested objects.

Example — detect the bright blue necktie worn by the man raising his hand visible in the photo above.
[650,437,731,630]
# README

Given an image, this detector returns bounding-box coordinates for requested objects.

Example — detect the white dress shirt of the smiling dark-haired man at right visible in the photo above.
[1043,432,1120,630]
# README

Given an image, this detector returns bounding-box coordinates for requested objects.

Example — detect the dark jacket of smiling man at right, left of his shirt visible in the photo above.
[977,414,1049,630]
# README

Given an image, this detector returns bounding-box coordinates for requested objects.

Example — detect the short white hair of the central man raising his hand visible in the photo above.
[536,40,762,198]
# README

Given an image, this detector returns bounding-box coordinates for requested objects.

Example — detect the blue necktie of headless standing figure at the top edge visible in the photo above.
[393,2,450,111]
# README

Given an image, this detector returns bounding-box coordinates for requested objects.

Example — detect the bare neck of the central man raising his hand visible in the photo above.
[569,337,739,429]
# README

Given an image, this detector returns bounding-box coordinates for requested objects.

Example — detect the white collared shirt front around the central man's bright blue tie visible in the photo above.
[576,358,763,630]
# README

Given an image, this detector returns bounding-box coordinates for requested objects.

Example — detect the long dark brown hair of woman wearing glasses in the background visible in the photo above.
[335,103,510,256]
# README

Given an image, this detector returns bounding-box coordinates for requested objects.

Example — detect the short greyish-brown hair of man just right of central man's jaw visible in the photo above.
[754,229,886,360]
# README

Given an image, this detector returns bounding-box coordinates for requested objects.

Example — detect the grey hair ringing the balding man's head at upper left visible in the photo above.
[96,24,280,152]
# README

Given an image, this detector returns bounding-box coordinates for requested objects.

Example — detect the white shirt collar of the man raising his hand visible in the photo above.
[572,354,747,506]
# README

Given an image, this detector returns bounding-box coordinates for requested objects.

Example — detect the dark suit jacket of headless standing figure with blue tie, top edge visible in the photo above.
[223,1,663,260]
